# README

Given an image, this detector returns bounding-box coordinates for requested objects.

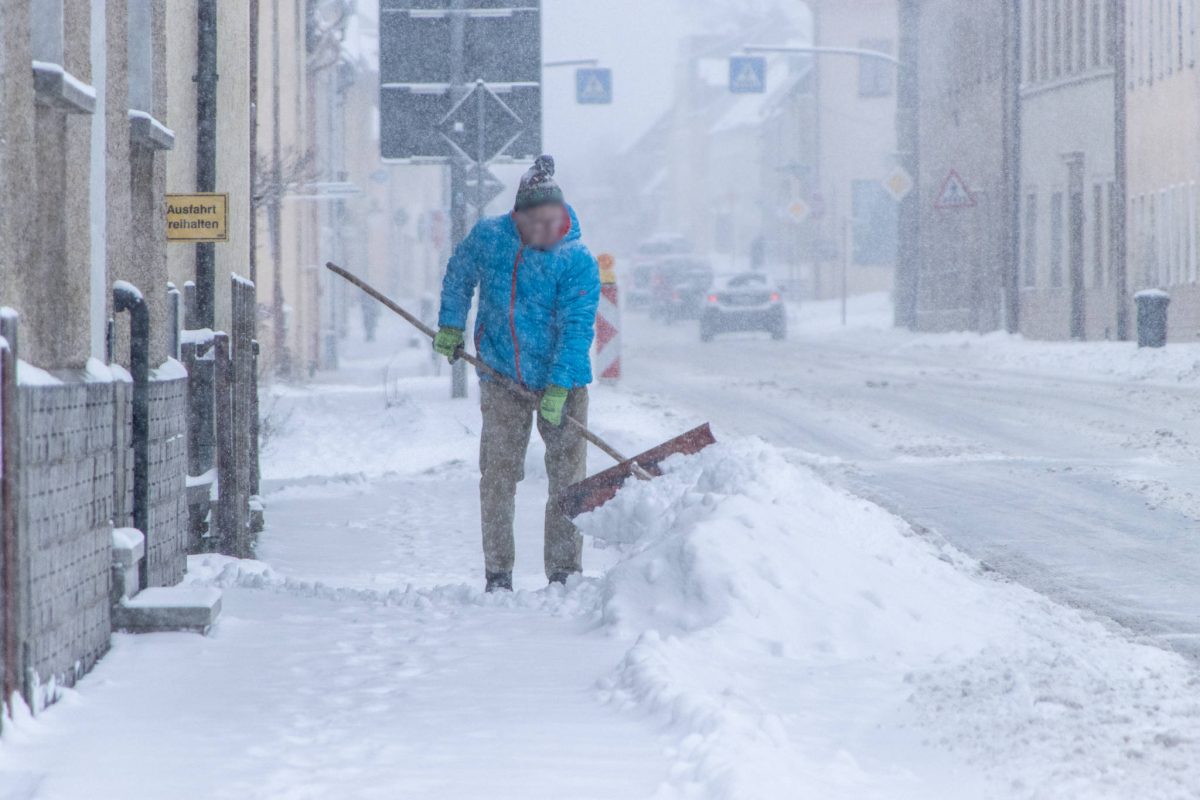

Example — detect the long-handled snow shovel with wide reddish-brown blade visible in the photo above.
[325,261,716,519]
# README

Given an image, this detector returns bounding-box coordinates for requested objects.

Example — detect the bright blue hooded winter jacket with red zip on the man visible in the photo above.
[438,207,600,391]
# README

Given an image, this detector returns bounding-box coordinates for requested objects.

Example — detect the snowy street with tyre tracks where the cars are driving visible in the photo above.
[625,297,1200,656]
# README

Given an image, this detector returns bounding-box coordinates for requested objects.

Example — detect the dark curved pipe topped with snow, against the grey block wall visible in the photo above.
[113,281,150,589]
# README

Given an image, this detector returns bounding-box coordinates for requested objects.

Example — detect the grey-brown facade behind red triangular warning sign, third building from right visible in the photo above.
[912,0,1016,331]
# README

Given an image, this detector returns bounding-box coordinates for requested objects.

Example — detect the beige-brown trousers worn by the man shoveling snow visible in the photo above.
[479,380,588,578]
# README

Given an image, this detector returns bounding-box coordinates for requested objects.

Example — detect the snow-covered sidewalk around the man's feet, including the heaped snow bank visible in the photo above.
[0,321,1200,800]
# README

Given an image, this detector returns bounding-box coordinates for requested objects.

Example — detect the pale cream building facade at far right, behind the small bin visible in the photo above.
[1123,0,1200,342]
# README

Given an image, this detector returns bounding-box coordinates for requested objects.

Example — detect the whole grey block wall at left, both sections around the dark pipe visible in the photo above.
[16,367,187,705]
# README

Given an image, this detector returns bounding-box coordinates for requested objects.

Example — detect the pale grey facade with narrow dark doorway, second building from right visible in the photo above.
[1020,0,1127,339]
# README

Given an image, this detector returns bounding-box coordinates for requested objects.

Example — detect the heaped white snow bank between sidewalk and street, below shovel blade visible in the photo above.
[580,440,1200,798]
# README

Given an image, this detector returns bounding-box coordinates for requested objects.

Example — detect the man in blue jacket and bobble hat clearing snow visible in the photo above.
[433,156,600,591]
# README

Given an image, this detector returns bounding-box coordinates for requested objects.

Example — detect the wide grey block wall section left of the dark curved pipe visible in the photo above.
[19,383,114,685]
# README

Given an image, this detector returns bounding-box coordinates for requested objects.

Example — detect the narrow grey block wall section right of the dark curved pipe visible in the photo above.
[145,378,187,587]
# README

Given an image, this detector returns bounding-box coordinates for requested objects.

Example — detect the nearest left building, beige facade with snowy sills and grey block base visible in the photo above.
[0,0,187,708]
